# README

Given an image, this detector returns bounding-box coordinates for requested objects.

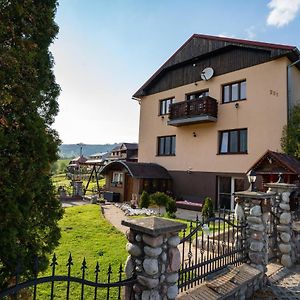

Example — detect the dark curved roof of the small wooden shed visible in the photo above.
[101,160,171,179]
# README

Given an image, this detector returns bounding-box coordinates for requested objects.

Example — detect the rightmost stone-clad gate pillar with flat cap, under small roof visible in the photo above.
[266,183,297,267]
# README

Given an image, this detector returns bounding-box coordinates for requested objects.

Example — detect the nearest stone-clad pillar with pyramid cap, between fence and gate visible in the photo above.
[122,217,186,300]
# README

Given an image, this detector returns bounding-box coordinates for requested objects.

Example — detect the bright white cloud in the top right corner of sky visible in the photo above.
[267,0,300,27]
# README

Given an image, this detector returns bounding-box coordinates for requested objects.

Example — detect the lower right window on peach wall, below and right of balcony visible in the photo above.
[219,129,248,154]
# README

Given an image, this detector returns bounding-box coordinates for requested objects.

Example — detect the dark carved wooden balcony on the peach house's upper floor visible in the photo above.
[168,96,218,126]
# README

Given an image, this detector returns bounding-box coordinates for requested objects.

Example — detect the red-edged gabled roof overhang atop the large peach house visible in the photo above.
[133,34,300,97]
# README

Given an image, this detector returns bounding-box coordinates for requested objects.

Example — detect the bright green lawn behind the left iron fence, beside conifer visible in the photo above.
[37,204,127,299]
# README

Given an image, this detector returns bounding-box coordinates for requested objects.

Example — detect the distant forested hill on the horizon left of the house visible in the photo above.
[59,143,119,158]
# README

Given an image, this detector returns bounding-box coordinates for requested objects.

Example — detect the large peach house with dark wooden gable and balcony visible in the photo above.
[133,34,300,209]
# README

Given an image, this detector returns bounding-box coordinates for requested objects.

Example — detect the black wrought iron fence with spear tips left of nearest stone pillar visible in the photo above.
[0,254,137,300]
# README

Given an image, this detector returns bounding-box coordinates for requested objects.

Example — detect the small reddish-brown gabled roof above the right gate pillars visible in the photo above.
[247,150,300,175]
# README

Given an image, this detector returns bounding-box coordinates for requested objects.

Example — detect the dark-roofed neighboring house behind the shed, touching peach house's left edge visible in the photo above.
[107,143,139,162]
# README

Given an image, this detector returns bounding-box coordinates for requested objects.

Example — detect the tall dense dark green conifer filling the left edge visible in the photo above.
[0,0,63,289]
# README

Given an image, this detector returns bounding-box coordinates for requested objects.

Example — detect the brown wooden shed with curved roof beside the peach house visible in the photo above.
[101,161,172,202]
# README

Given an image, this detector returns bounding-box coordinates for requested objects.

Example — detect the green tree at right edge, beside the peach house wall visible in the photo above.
[281,105,300,159]
